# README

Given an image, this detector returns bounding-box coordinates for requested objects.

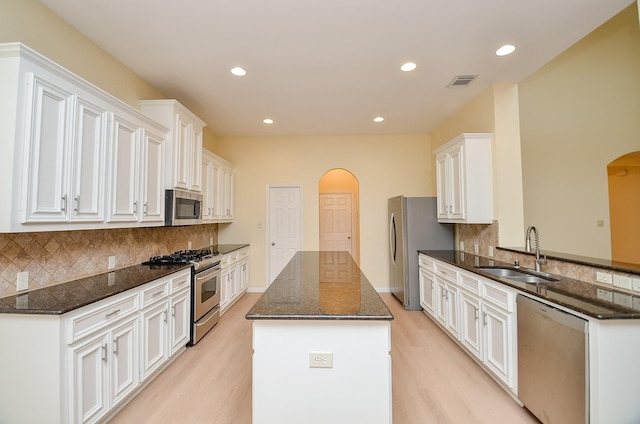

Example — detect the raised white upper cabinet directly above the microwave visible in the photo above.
[140,100,207,192]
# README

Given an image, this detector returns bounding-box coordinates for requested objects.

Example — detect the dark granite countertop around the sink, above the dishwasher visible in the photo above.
[418,250,640,319]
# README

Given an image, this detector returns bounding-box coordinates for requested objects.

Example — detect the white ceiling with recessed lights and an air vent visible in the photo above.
[40,0,634,136]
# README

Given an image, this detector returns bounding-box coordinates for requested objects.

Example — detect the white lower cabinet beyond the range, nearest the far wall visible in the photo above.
[220,246,249,313]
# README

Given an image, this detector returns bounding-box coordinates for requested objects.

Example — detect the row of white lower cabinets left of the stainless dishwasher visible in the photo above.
[420,254,517,393]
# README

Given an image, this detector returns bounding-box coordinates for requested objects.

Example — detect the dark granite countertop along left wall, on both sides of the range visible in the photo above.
[0,244,249,315]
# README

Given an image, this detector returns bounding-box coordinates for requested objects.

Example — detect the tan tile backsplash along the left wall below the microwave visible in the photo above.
[0,224,218,297]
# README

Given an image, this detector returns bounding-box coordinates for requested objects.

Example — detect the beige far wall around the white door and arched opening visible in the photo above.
[219,134,435,288]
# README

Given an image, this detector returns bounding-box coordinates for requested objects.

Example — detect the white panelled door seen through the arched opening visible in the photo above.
[320,193,353,254]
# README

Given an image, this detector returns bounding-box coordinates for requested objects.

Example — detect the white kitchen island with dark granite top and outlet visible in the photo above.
[246,252,393,424]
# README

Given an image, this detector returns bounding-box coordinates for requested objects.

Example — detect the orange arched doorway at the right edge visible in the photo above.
[607,152,640,264]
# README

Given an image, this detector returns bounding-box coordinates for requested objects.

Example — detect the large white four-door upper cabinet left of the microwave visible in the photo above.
[0,43,167,232]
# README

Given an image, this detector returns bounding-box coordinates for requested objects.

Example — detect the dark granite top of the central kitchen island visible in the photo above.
[246,252,393,320]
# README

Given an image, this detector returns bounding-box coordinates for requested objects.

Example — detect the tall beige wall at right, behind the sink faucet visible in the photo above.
[519,4,640,258]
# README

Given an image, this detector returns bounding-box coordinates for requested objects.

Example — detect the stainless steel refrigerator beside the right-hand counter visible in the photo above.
[389,196,454,310]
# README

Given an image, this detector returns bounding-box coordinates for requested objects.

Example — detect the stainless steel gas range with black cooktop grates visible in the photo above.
[144,249,220,346]
